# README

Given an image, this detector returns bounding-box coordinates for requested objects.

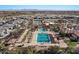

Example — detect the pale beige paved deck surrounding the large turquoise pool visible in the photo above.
[31,31,58,46]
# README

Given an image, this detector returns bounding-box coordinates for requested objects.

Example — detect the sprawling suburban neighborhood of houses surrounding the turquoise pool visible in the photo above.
[0,10,79,54]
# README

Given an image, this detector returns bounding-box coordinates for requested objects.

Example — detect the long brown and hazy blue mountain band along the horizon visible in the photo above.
[0,9,79,16]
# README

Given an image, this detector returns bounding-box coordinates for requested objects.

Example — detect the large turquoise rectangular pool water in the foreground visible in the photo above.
[37,33,51,43]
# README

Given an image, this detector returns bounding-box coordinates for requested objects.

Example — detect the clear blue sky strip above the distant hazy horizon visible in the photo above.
[0,5,79,10]
